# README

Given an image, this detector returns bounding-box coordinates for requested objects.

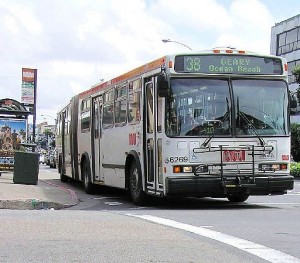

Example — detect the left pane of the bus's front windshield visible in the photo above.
[166,79,231,136]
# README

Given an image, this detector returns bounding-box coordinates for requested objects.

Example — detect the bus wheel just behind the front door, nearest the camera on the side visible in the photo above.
[129,162,146,205]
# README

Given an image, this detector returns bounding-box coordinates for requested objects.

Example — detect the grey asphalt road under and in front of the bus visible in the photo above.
[0,167,300,263]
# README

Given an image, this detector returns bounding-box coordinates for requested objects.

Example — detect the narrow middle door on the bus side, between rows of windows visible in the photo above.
[91,96,104,182]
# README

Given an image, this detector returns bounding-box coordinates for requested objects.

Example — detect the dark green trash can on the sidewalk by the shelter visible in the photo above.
[13,151,39,185]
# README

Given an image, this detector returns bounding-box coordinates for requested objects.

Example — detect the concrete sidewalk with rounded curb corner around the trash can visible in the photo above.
[0,169,79,210]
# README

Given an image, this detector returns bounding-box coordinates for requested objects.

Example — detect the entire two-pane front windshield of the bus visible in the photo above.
[166,78,288,137]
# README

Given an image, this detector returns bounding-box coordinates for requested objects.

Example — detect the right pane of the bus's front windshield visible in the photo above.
[232,80,288,135]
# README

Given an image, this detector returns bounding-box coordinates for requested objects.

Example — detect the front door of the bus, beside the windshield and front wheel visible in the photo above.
[145,78,163,195]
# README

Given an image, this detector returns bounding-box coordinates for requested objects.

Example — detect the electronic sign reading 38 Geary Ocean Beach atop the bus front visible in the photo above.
[175,55,283,75]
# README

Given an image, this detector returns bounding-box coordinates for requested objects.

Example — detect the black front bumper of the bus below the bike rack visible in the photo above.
[166,174,294,197]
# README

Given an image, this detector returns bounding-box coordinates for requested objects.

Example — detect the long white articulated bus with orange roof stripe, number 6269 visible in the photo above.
[56,48,294,204]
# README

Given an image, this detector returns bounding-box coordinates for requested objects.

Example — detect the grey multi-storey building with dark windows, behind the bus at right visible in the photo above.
[270,14,300,92]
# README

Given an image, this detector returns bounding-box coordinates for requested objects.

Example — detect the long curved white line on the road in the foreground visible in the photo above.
[127,214,300,263]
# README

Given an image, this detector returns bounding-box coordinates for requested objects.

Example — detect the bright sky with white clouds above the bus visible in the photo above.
[0,0,300,123]
